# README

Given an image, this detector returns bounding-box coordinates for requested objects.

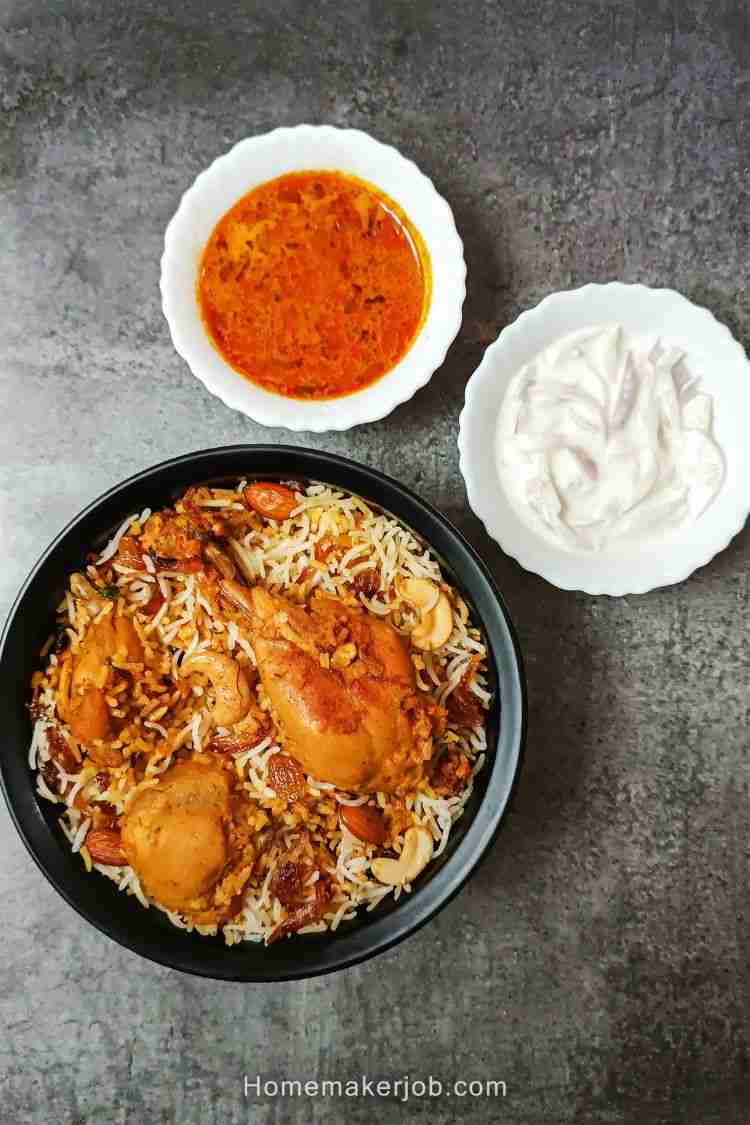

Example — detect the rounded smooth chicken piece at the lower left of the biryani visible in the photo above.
[121,758,255,921]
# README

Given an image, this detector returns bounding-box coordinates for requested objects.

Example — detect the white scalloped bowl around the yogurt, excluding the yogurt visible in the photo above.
[459,281,750,595]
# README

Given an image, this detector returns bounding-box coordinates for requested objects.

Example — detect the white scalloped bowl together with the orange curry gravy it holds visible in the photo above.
[161,125,466,433]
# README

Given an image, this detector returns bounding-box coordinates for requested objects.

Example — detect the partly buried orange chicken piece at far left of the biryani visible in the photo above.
[57,613,144,743]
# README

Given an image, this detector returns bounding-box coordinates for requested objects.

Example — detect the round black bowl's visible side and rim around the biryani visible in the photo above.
[0,446,526,981]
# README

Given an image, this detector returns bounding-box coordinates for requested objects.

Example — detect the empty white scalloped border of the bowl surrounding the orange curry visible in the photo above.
[160,125,467,433]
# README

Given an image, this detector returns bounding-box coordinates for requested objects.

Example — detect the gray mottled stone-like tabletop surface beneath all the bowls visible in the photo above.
[0,0,750,1125]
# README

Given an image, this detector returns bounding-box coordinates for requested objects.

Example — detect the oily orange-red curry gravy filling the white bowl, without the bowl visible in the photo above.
[198,172,431,399]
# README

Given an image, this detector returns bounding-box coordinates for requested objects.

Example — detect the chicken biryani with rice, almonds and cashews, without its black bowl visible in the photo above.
[29,480,491,945]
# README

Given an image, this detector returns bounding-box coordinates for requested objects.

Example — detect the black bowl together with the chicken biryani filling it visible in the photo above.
[0,446,525,981]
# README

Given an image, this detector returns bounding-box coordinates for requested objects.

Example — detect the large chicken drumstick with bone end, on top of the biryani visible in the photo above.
[222,582,432,792]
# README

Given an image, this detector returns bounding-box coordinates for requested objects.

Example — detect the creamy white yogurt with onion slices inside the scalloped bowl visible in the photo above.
[496,324,724,550]
